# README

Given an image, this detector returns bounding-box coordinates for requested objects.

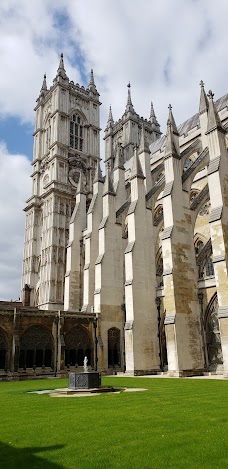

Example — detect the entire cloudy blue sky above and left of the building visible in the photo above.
[0,0,228,300]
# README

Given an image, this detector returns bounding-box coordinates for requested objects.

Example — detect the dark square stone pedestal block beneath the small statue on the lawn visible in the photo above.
[68,371,101,389]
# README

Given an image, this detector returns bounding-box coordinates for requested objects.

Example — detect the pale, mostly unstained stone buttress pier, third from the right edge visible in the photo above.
[125,148,159,374]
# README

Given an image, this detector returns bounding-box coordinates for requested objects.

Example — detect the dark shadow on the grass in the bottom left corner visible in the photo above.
[0,442,64,469]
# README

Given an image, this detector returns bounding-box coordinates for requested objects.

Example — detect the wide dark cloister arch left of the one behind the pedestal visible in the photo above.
[19,326,53,369]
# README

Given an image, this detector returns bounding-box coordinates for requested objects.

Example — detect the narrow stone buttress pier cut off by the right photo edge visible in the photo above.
[207,91,228,376]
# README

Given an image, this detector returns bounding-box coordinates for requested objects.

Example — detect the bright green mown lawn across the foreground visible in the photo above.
[0,377,228,469]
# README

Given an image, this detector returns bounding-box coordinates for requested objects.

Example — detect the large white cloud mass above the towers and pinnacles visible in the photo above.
[0,0,228,128]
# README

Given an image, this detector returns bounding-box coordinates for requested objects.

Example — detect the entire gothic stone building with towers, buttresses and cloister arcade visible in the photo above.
[0,56,228,379]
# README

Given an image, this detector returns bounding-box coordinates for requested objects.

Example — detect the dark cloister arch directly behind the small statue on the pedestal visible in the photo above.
[65,326,92,368]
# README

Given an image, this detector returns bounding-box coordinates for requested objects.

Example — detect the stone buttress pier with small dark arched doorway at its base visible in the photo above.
[94,166,124,370]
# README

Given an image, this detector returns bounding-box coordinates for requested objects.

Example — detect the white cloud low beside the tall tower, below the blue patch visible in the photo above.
[0,142,31,300]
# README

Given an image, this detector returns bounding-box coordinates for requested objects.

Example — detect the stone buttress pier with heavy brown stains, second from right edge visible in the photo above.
[162,119,203,374]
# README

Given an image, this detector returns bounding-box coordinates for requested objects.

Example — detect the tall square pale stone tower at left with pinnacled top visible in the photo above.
[22,54,100,310]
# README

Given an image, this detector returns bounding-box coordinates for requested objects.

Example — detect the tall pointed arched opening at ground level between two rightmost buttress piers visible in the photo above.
[204,293,223,371]
